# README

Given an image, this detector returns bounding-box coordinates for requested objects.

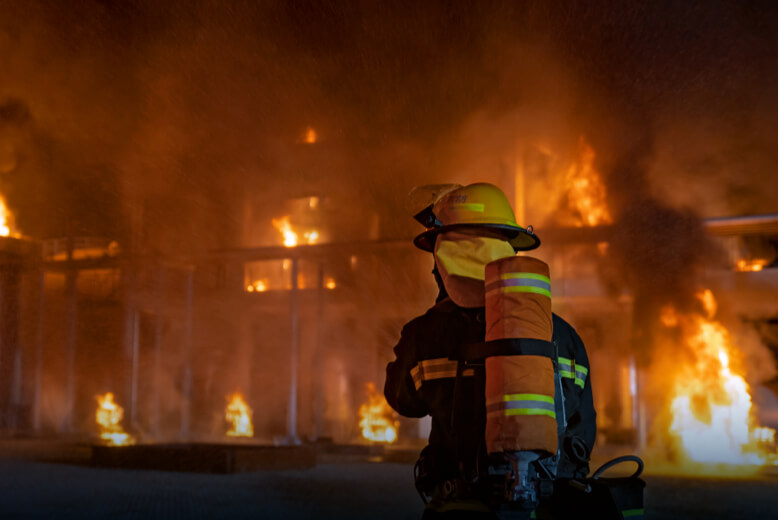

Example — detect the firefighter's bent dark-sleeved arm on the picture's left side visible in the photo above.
[384,322,429,417]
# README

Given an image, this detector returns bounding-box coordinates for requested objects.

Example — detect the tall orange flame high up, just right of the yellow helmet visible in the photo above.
[565,137,613,226]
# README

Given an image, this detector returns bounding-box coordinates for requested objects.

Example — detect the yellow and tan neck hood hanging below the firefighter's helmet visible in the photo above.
[435,231,515,308]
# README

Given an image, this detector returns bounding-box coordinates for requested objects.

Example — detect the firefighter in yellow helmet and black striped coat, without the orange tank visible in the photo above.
[384,183,596,519]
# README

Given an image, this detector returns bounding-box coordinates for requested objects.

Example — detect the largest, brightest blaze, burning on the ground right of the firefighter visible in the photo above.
[661,290,777,475]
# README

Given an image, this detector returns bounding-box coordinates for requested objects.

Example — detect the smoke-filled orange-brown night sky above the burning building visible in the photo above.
[0,0,778,250]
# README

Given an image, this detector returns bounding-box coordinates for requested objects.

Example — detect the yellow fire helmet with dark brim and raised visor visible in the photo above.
[408,182,540,252]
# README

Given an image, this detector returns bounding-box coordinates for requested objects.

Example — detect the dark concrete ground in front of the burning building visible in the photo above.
[0,445,778,520]
